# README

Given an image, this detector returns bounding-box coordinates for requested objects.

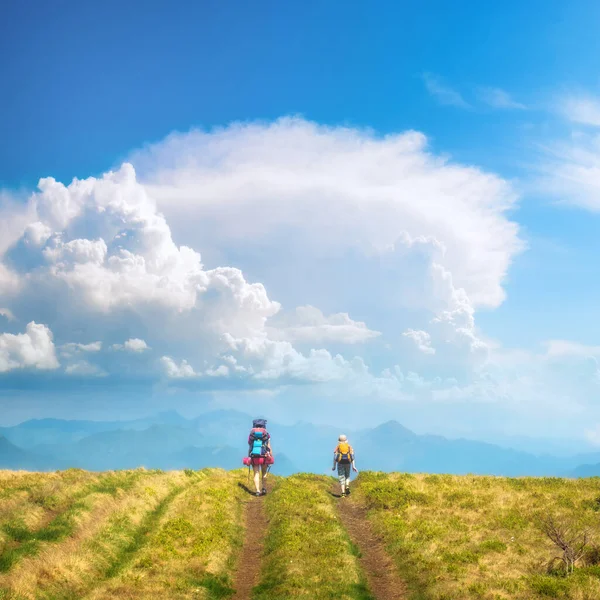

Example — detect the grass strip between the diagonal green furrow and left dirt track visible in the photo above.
[89,469,247,600]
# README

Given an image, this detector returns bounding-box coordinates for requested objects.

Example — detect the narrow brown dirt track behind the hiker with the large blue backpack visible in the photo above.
[231,484,271,600]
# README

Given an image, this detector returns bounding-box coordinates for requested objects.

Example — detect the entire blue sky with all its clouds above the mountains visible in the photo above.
[0,0,600,445]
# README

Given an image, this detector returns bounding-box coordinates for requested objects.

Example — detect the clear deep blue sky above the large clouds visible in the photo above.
[0,1,600,186]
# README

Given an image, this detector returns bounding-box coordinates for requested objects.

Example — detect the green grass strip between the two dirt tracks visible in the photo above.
[252,475,372,600]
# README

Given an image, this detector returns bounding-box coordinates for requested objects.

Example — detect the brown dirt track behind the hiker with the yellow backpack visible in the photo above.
[338,498,408,600]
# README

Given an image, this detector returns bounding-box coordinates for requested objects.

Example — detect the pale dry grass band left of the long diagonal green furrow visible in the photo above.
[0,469,191,600]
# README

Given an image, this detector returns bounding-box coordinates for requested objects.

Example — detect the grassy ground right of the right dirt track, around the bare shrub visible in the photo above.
[355,473,600,600]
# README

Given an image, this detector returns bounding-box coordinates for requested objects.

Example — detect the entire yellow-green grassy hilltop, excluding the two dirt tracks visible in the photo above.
[0,469,600,600]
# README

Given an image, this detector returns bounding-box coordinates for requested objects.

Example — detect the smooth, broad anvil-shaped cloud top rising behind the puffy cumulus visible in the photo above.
[132,118,522,307]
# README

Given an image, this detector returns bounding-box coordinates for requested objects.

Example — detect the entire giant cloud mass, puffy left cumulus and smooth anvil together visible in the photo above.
[0,119,521,397]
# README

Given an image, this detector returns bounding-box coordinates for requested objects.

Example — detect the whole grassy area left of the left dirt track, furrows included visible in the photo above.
[0,469,244,600]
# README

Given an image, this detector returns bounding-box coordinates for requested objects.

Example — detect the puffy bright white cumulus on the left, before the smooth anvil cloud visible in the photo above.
[2,164,375,382]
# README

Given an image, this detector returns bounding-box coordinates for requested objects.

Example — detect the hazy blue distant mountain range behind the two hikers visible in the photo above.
[0,410,600,477]
